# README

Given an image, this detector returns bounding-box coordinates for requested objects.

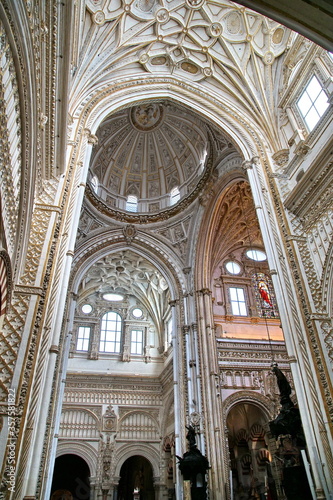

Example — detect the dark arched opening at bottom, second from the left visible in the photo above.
[118,455,155,500]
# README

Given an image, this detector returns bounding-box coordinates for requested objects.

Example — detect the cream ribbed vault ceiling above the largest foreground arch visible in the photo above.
[71,0,293,150]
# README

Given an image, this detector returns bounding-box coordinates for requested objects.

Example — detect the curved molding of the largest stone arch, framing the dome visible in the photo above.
[70,77,264,174]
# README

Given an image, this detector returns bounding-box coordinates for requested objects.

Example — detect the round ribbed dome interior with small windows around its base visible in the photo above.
[89,100,228,212]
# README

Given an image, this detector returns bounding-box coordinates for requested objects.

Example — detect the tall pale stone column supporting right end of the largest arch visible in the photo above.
[243,157,331,498]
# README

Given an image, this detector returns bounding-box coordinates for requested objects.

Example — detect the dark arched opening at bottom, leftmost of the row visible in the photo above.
[51,454,90,500]
